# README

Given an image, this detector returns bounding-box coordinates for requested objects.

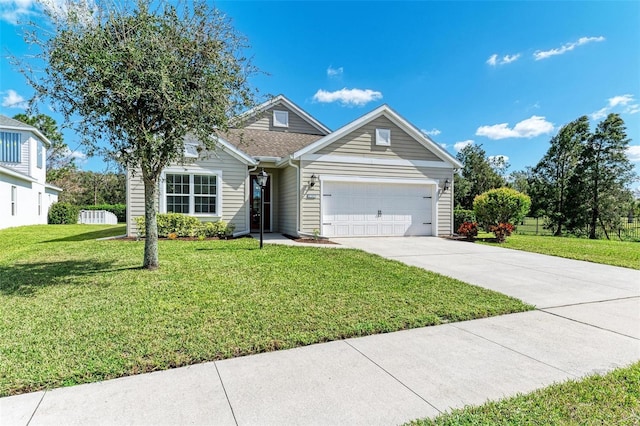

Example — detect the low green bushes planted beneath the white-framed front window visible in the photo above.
[135,213,235,238]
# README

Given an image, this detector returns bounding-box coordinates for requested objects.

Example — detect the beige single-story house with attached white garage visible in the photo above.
[127,95,462,237]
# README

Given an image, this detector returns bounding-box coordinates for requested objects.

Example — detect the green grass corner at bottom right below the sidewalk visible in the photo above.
[410,363,640,426]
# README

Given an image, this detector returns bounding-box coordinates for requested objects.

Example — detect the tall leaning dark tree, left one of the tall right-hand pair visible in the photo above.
[529,116,590,235]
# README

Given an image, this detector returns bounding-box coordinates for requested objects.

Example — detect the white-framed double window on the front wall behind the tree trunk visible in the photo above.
[165,173,219,215]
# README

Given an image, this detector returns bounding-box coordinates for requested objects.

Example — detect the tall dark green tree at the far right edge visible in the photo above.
[570,114,636,239]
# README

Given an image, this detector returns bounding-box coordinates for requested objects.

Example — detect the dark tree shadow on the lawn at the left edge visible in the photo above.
[0,260,142,296]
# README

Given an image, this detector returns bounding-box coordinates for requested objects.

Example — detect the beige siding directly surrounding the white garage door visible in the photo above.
[300,161,453,235]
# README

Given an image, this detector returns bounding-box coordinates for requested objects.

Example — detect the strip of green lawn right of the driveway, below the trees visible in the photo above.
[477,233,640,269]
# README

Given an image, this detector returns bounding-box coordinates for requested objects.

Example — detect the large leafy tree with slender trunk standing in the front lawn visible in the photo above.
[23,0,254,269]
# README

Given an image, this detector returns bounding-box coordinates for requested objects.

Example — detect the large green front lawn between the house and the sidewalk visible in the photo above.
[0,225,532,396]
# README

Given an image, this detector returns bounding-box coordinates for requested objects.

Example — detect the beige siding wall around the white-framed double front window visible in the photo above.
[127,150,249,236]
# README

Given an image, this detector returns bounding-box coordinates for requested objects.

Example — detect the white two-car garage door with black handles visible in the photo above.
[322,181,433,237]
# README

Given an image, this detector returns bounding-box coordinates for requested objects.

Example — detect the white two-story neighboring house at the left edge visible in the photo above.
[0,115,62,229]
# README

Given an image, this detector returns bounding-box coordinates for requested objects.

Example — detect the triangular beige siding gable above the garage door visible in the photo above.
[315,116,442,161]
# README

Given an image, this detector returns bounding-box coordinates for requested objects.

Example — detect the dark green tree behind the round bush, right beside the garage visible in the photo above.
[454,144,506,210]
